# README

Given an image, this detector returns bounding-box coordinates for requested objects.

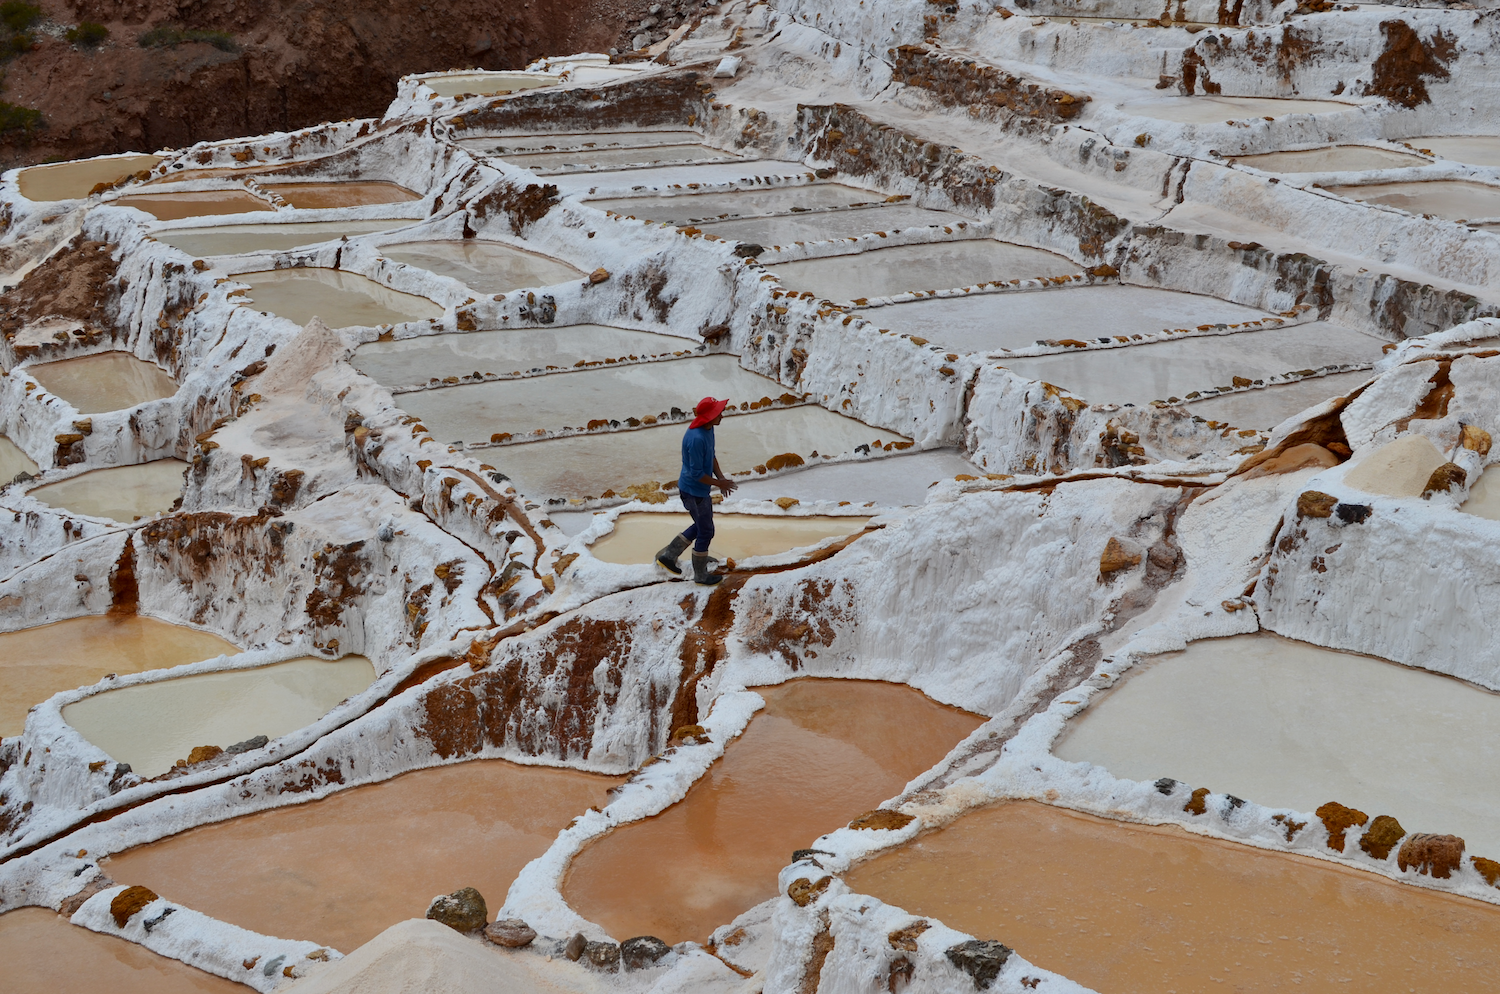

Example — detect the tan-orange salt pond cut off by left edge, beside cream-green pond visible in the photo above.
[0,615,239,738]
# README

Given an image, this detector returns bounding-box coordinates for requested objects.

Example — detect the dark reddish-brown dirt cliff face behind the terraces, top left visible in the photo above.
[0,0,650,168]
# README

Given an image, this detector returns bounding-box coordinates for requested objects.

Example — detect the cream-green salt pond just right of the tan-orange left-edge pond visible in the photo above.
[63,655,375,777]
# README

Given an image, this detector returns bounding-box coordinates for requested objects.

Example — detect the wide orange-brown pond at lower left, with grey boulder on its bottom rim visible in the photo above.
[102,760,623,952]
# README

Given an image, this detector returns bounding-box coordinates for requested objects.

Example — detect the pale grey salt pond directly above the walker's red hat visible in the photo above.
[401,355,786,444]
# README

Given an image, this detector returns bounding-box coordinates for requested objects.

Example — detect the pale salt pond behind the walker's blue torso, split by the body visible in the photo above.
[492,397,909,499]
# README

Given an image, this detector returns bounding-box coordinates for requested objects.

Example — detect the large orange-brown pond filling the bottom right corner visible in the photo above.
[845,802,1500,994]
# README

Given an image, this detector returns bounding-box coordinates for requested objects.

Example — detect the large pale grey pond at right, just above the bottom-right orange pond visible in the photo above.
[1053,633,1500,856]
